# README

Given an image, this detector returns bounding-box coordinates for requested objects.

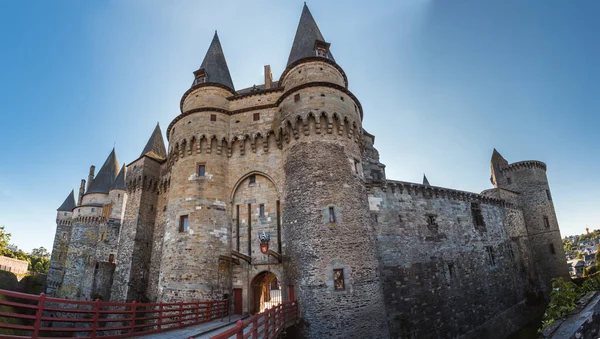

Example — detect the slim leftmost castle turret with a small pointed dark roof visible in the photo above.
[46,191,75,296]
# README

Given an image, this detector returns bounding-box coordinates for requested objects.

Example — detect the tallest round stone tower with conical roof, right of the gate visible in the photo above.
[279,5,389,338]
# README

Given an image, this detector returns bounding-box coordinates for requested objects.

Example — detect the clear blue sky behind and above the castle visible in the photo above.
[0,0,600,251]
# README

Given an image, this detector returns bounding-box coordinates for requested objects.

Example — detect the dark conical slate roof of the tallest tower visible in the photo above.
[287,2,335,66]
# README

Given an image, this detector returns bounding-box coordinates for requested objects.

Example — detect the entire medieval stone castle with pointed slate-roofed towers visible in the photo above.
[47,5,568,338]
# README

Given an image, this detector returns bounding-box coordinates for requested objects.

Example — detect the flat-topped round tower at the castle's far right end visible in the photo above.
[491,149,569,295]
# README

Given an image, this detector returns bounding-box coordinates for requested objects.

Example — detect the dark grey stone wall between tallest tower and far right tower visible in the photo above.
[369,182,537,338]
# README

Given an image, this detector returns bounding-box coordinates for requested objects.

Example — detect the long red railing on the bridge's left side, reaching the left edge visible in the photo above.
[0,290,229,339]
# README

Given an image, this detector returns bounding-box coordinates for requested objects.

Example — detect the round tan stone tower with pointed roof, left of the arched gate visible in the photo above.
[159,32,235,301]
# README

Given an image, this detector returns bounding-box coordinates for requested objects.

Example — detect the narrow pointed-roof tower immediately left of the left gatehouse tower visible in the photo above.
[110,124,166,302]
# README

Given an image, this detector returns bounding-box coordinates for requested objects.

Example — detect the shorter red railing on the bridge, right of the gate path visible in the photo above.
[210,301,298,339]
